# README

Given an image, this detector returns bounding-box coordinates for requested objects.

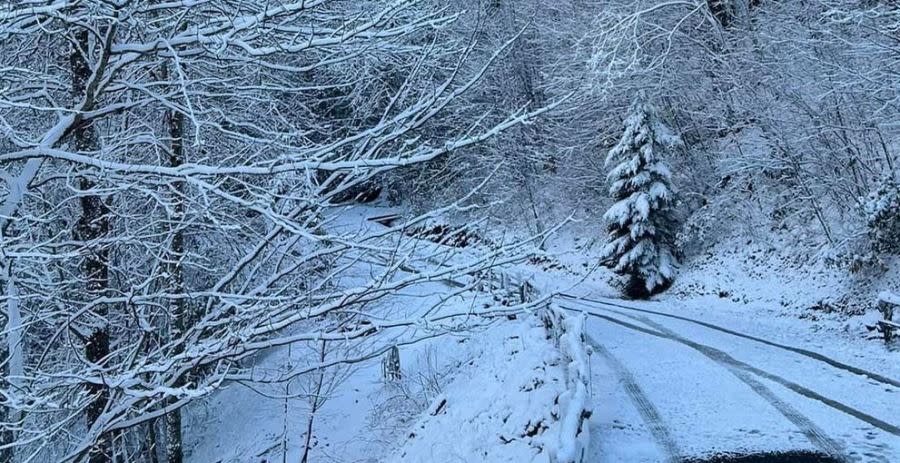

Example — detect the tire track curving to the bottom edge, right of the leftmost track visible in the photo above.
[610,310,849,462]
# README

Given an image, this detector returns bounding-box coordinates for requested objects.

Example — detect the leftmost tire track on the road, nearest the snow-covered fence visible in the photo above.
[585,335,682,463]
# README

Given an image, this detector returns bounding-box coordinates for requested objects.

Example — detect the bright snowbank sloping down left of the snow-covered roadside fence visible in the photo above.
[388,311,590,463]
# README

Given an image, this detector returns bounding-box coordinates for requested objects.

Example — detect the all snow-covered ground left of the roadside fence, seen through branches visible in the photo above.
[184,207,588,463]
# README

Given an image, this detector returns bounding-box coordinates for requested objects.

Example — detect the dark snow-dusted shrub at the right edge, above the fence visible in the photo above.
[863,176,900,254]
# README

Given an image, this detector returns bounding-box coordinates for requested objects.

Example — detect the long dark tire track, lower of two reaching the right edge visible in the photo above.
[560,306,900,437]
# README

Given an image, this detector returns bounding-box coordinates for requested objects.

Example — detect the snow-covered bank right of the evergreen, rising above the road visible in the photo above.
[669,238,900,326]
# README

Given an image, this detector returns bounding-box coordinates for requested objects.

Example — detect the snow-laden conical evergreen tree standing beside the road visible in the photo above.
[601,100,680,298]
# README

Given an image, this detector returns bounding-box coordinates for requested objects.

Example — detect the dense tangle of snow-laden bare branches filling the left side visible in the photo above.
[0,0,540,462]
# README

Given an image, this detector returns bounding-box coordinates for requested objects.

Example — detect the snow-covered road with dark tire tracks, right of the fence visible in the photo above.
[559,297,900,463]
